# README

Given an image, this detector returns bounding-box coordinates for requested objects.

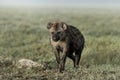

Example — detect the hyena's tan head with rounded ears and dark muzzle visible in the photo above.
[47,22,67,42]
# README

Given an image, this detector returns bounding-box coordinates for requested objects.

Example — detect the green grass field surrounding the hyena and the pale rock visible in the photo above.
[0,7,120,80]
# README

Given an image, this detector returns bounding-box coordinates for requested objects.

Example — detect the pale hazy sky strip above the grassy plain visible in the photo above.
[0,0,120,7]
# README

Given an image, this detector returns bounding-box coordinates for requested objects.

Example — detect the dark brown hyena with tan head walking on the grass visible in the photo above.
[47,21,85,72]
